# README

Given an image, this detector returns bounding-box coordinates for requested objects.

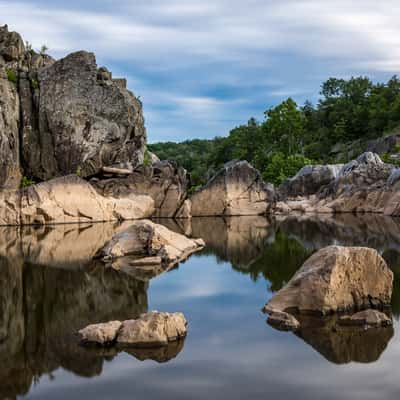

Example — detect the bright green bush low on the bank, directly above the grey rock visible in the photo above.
[262,153,313,185]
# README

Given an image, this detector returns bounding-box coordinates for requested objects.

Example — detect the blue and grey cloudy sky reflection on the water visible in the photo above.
[24,252,400,400]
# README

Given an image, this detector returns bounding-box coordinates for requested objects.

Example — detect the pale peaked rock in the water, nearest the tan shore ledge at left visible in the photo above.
[99,220,204,269]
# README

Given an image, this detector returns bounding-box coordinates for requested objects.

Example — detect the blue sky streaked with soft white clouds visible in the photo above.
[0,0,400,143]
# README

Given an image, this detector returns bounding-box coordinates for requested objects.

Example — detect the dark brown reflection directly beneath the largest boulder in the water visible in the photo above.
[296,315,394,364]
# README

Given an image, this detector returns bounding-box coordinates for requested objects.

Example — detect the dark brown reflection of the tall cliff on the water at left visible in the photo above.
[0,257,147,397]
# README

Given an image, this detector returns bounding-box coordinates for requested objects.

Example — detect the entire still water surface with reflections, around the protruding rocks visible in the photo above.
[0,215,400,400]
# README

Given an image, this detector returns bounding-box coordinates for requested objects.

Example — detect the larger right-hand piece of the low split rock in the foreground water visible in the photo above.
[117,311,187,347]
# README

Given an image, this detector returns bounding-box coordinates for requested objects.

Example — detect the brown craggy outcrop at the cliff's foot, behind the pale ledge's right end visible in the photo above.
[92,161,188,218]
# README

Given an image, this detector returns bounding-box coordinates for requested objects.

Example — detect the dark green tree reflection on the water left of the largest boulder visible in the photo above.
[232,230,313,291]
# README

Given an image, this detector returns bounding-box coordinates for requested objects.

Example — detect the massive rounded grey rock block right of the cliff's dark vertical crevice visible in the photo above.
[33,51,146,179]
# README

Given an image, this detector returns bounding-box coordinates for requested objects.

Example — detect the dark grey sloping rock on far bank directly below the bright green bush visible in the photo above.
[279,164,343,197]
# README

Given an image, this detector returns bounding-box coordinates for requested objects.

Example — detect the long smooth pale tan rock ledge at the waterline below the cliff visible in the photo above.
[0,175,154,225]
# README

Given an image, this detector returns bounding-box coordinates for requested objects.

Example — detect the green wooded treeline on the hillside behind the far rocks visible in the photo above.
[148,76,400,187]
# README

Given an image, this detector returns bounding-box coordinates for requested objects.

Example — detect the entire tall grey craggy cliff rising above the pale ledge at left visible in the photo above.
[0,25,146,188]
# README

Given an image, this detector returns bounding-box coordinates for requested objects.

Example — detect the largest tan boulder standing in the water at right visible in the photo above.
[264,246,393,314]
